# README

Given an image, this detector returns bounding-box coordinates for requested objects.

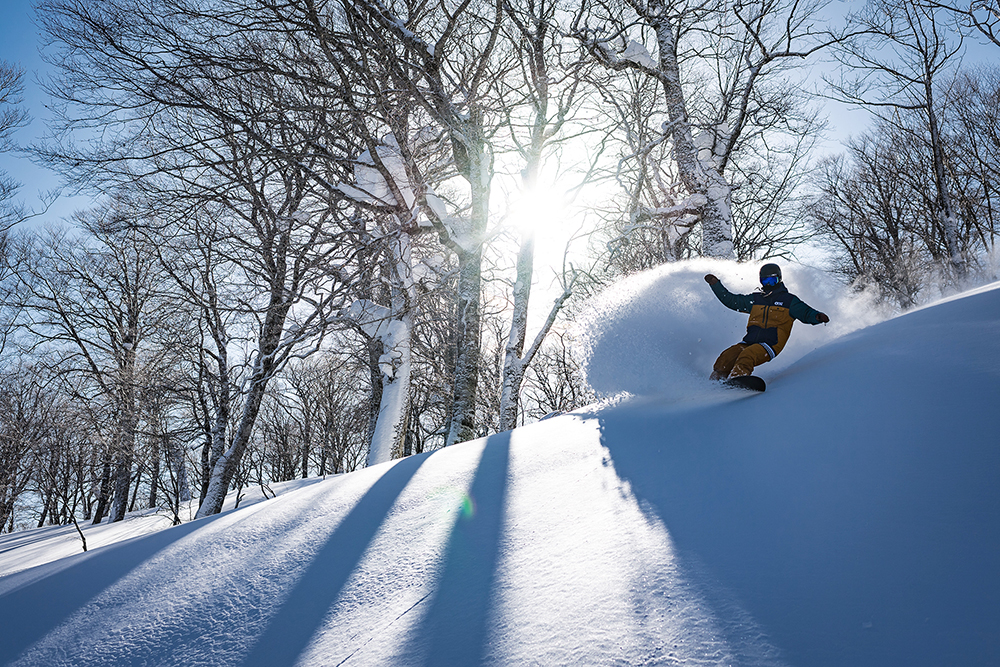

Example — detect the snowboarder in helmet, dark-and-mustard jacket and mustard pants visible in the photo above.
[705,264,830,380]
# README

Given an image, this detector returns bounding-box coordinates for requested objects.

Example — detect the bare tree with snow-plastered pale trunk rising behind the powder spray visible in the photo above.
[573,0,845,260]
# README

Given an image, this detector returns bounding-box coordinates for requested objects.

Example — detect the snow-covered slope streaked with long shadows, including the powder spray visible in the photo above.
[0,267,1000,667]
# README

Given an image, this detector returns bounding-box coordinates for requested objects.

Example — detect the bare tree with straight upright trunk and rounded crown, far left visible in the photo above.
[18,206,172,522]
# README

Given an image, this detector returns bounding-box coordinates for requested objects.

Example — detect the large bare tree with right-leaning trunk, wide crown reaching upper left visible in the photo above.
[39,0,364,516]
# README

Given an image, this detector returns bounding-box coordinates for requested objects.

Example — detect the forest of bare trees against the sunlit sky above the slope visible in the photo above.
[0,0,1000,535]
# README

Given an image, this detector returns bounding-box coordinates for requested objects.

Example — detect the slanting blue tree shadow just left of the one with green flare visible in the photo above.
[243,454,428,667]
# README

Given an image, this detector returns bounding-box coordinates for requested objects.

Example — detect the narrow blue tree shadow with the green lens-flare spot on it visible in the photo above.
[413,432,510,667]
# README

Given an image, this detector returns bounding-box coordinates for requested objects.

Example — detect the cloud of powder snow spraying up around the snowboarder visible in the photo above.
[576,258,888,399]
